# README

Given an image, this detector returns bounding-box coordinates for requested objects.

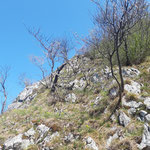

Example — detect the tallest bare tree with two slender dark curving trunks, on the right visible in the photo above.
[92,0,147,117]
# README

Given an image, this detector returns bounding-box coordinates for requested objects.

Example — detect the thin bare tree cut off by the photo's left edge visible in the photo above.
[0,66,10,114]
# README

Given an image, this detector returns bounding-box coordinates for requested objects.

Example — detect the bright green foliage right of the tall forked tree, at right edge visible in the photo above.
[114,20,150,65]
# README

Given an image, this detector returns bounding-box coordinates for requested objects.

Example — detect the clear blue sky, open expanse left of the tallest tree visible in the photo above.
[0,0,94,109]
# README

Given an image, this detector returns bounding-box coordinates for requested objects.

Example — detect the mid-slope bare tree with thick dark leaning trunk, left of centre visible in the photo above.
[27,29,71,92]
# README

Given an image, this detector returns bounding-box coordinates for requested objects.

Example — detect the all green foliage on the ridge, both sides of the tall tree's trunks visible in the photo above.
[85,18,150,65]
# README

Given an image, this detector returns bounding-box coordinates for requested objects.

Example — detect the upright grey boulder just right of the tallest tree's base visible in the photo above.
[118,112,131,127]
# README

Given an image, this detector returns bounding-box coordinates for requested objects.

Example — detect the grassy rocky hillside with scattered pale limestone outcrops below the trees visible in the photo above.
[0,56,150,150]
